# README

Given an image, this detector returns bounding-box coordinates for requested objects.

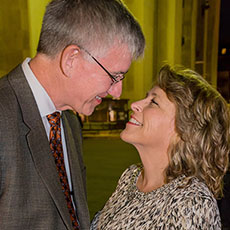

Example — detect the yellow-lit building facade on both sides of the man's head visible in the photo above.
[0,0,221,106]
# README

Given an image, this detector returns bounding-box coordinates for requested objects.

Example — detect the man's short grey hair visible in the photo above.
[37,0,145,59]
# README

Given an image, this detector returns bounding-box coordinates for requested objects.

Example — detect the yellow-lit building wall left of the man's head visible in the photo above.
[0,0,49,76]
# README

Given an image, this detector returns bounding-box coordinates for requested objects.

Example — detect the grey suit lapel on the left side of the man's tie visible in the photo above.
[8,67,72,229]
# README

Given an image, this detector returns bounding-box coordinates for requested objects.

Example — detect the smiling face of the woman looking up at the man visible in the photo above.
[121,86,176,149]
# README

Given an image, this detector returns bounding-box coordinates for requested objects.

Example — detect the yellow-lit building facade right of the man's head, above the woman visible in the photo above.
[123,0,221,100]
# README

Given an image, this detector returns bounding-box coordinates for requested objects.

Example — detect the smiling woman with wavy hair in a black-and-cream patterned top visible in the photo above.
[91,65,230,230]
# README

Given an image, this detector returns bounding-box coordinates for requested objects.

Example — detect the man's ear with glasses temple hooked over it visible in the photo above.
[60,45,80,77]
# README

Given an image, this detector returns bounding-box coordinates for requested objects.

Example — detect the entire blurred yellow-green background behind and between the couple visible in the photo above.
[0,0,230,217]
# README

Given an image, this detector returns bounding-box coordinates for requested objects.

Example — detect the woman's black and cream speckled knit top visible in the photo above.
[90,165,221,230]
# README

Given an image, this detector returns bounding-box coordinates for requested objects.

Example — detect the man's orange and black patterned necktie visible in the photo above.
[47,112,79,229]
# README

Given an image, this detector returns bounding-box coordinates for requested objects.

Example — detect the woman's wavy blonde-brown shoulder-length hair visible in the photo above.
[156,65,230,198]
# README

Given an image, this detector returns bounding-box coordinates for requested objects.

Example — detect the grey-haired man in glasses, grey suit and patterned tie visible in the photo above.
[0,0,145,230]
